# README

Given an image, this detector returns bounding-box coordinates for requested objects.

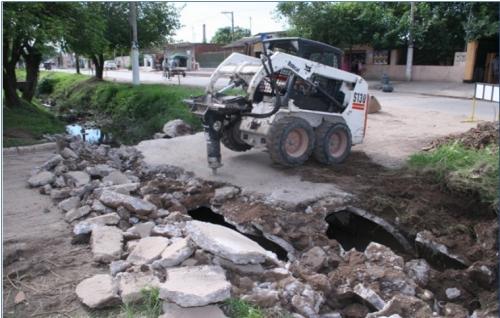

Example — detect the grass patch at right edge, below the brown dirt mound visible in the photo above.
[408,142,499,206]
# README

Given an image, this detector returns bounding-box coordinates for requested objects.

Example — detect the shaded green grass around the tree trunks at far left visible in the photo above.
[3,102,64,147]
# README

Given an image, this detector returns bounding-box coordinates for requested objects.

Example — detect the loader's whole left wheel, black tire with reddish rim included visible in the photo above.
[267,117,314,167]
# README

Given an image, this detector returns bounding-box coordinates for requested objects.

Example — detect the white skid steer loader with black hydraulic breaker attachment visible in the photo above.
[185,38,369,173]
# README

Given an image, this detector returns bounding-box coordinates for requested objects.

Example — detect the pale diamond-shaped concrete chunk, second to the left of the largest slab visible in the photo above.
[127,236,169,265]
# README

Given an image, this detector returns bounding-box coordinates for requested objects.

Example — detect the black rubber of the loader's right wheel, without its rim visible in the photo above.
[313,122,352,165]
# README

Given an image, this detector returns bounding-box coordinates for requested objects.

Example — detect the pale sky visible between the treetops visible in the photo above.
[174,2,287,42]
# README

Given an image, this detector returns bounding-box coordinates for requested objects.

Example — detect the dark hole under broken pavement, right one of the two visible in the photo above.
[325,209,411,253]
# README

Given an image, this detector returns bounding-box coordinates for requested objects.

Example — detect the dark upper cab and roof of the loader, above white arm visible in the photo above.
[263,37,343,68]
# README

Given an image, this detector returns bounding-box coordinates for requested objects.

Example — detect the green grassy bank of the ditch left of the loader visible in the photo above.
[44,72,203,144]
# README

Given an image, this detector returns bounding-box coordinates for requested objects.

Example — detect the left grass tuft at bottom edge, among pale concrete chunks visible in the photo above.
[122,288,163,318]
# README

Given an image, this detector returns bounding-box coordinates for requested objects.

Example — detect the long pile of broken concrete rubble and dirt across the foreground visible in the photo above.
[28,137,498,318]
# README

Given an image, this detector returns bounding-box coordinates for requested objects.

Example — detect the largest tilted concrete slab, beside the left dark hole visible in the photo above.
[186,221,276,264]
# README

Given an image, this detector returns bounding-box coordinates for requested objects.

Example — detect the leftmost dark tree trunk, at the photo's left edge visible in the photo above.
[2,36,21,107]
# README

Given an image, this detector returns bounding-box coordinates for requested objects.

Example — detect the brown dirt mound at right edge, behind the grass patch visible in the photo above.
[424,121,499,150]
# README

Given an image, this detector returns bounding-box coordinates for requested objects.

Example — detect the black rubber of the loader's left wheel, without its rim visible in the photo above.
[267,117,315,167]
